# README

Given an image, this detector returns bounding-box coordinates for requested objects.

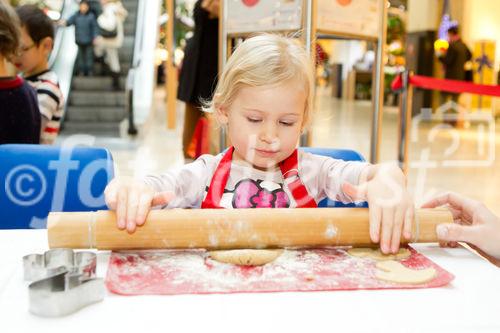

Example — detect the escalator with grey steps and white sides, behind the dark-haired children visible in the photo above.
[12,0,154,137]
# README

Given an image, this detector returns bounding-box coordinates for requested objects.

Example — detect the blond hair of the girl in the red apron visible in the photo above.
[203,34,314,127]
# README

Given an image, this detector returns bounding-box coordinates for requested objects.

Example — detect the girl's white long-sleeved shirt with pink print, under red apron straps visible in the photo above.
[144,151,369,208]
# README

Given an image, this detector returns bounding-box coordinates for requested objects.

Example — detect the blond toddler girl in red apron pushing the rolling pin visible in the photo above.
[105,34,414,253]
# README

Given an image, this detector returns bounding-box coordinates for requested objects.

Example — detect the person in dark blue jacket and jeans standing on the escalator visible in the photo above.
[63,0,98,76]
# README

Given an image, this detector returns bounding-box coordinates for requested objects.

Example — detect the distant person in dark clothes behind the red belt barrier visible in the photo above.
[439,26,472,102]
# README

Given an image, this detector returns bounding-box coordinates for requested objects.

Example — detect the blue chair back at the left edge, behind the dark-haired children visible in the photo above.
[0,144,114,229]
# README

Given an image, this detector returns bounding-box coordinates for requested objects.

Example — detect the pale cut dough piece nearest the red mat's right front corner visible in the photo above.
[375,260,437,284]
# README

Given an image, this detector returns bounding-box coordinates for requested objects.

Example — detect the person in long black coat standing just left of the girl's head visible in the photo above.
[177,0,219,158]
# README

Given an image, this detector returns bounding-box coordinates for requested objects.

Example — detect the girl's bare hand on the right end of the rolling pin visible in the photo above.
[342,164,415,254]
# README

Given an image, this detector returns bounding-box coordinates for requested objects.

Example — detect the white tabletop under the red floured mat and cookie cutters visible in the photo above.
[0,230,500,333]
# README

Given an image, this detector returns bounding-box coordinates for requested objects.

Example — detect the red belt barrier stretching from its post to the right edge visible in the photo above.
[391,75,500,97]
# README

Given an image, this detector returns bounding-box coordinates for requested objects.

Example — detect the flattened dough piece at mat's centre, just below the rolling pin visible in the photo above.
[208,249,283,266]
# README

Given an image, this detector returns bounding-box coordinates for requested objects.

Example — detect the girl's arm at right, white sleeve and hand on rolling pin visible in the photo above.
[300,153,414,253]
